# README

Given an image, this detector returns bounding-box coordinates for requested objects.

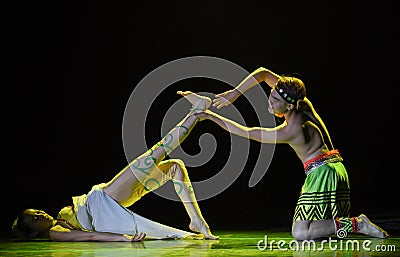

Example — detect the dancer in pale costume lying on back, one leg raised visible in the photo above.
[13,91,218,242]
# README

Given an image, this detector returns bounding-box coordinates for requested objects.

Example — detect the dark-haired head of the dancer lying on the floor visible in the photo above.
[12,209,54,239]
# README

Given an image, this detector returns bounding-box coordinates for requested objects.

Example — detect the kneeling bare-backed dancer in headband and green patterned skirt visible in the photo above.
[196,68,387,240]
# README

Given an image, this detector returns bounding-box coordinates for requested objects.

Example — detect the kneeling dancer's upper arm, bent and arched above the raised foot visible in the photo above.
[213,67,280,109]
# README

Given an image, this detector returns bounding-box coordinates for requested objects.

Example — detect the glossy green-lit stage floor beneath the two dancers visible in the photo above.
[0,231,400,257]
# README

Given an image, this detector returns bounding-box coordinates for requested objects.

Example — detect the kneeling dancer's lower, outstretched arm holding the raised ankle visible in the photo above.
[195,110,290,144]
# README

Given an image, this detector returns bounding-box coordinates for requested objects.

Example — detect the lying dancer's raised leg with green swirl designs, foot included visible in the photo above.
[104,91,211,207]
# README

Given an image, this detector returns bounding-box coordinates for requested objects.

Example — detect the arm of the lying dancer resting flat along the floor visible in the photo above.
[49,225,146,242]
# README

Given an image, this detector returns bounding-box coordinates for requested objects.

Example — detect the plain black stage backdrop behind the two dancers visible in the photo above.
[0,1,400,237]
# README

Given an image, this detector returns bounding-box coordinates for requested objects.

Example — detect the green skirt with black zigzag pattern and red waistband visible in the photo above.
[293,150,350,222]
